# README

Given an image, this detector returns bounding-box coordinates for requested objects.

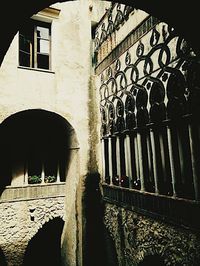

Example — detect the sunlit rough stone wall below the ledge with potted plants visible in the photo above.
[0,197,65,266]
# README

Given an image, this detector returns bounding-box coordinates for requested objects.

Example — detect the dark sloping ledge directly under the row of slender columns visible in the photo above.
[103,184,200,231]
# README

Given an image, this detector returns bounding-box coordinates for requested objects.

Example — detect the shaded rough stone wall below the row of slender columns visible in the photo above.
[104,203,200,266]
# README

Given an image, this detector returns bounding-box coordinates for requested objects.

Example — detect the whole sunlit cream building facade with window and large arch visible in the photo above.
[0,2,110,266]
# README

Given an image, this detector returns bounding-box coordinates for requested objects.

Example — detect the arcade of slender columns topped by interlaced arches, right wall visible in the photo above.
[96,7,200,214]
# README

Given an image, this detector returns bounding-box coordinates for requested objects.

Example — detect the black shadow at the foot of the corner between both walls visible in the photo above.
[84,173,118,266]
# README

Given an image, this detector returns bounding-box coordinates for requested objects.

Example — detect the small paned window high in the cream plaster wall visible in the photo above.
[19,19,51,70]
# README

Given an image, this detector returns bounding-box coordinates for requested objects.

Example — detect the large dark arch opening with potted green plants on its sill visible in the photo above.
[0,109,77,187]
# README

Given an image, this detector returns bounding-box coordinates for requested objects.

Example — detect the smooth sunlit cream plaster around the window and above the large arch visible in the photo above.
[0,1,90,179]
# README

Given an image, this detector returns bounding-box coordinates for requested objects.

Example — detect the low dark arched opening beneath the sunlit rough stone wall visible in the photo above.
[22,218,64,266]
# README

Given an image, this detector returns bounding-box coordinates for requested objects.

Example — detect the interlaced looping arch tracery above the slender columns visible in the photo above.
[101,18,196,138]
